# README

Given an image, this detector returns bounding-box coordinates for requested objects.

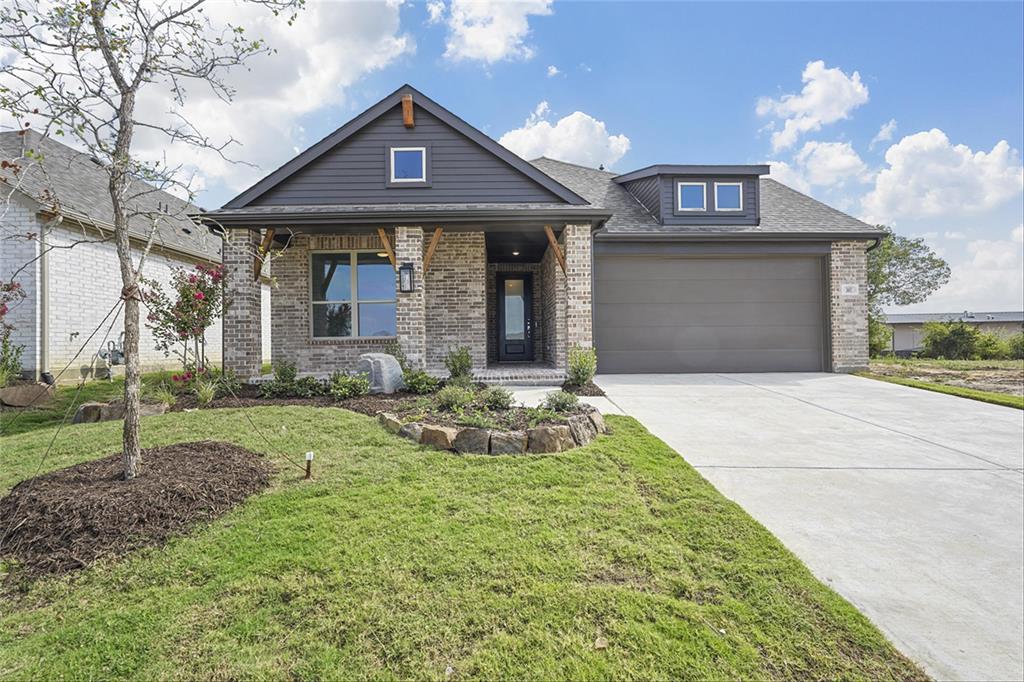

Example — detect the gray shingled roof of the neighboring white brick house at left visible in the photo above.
[0,130,221,260]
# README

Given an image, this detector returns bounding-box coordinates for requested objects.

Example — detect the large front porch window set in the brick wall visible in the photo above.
[311,251,396,339]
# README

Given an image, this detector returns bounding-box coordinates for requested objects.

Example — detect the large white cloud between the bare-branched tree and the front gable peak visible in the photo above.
[128,2,415,199]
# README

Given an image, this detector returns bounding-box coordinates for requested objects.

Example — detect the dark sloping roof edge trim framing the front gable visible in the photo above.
[223,84,587,209]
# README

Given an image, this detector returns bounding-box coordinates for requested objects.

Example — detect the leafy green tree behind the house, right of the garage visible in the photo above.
[867,225,949,353]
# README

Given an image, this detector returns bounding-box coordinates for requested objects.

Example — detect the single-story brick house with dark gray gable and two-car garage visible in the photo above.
[200,85,880,381]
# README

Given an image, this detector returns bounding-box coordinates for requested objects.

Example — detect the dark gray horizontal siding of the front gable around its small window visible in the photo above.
[252,105,562,206]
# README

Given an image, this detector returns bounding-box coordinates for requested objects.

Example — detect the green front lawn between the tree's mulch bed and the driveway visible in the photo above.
[0,408,924,680]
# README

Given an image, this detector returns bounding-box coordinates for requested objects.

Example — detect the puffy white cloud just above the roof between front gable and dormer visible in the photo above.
[498,101,630,168]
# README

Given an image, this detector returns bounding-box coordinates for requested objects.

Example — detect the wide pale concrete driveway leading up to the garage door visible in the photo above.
[597,374,1024,680]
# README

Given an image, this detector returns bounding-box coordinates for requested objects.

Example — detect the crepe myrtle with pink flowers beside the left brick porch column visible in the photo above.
[144,263,224,384]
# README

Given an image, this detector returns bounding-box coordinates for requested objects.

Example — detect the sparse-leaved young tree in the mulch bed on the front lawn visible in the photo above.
[0,0,303,479]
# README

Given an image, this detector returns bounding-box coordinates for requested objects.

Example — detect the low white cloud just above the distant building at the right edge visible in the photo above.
[899,225,1024,312]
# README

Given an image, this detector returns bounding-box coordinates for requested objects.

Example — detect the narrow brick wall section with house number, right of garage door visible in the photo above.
[828,241,870,372]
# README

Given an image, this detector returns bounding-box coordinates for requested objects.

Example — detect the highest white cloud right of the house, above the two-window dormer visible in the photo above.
[757,59,868,152]
